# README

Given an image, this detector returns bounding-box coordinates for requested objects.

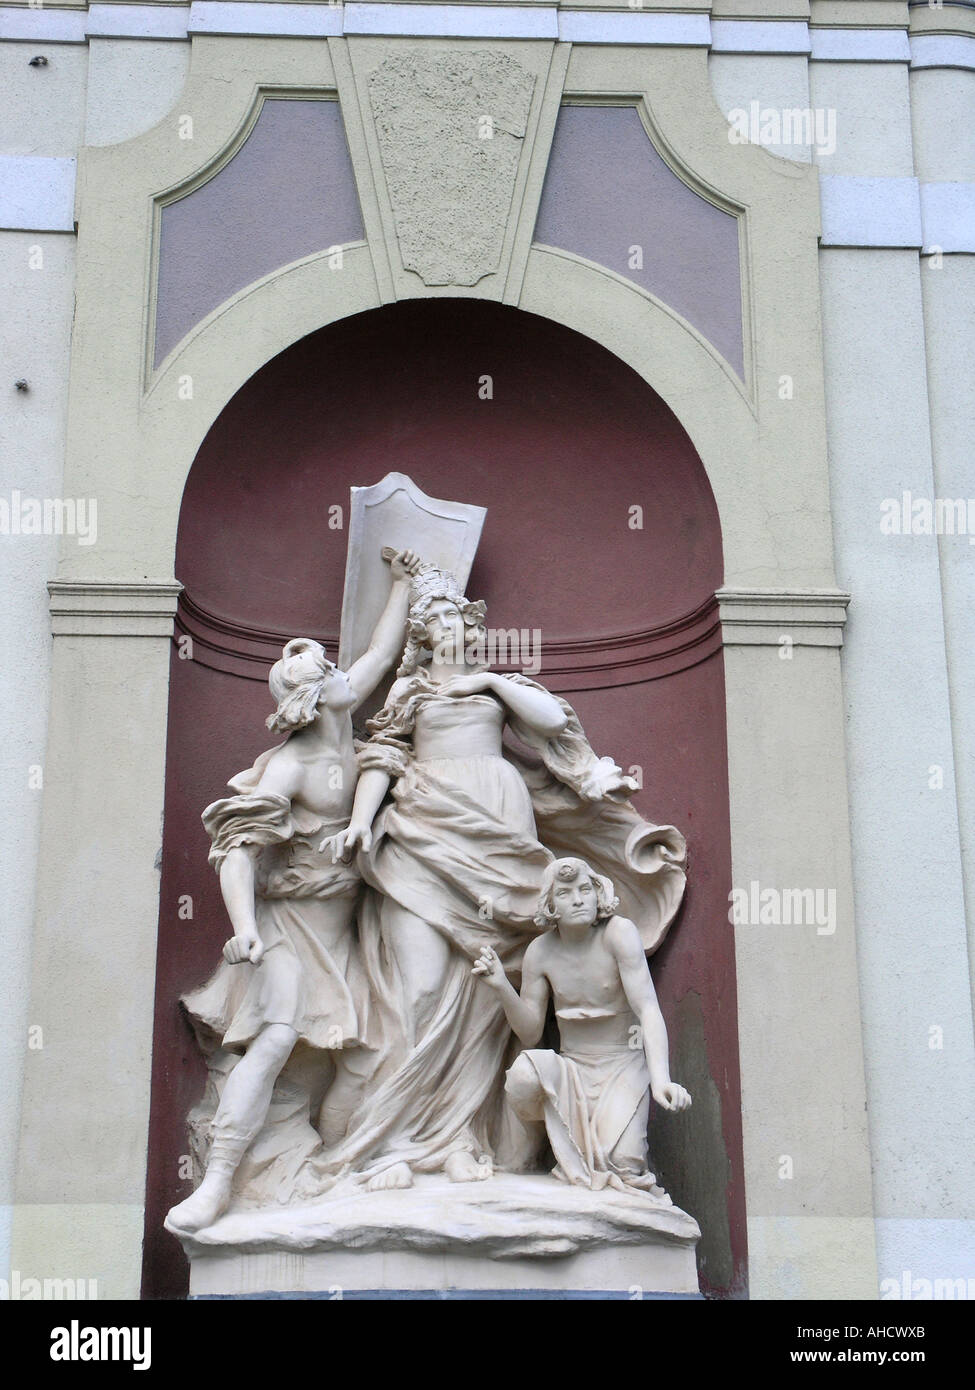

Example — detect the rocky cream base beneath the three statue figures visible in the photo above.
[181,1173,701,1298]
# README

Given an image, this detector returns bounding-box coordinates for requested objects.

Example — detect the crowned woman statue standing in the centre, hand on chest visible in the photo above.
[322,566,569,1188]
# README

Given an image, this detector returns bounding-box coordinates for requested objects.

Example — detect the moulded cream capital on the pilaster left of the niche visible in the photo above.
[47,580,182,637]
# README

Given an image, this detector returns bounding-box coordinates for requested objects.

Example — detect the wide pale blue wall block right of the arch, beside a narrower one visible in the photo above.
[819,174,921,249]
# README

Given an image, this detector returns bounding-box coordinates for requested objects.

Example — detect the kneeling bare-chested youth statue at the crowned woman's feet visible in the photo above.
[473,859,691,1197]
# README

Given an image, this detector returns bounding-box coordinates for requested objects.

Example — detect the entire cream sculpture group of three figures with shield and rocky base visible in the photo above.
[167,475,698,1289]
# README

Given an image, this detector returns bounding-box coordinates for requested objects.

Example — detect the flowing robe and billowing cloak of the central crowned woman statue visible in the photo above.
[315,670,684,1176]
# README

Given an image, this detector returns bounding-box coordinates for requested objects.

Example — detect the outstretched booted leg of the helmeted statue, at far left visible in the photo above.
[166,1023,298,1230]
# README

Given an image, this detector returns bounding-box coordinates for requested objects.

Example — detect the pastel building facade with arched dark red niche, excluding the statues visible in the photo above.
[0,0,975,1298]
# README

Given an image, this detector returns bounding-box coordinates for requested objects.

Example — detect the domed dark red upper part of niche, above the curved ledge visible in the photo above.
[177,300,722,638]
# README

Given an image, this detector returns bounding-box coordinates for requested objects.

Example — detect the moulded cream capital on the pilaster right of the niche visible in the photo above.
[715,588,850,646]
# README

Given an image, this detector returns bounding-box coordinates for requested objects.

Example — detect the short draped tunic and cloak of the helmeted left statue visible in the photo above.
[176,749,373,1207]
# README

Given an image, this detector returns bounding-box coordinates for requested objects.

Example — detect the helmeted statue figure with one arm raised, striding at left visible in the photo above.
[166,550,419,1232]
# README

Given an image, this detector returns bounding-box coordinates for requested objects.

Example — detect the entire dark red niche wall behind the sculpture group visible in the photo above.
[143,299,746,1298]
